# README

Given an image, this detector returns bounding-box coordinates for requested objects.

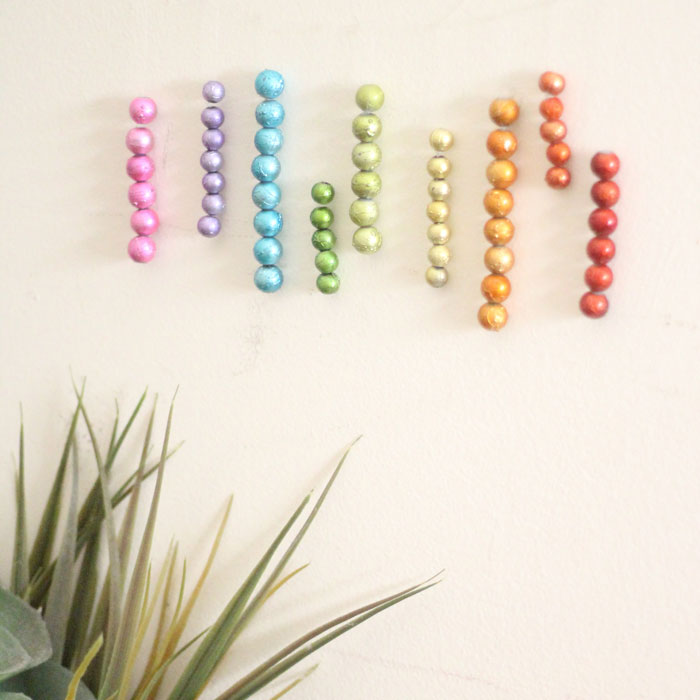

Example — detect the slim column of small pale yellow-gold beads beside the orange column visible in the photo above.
[425,129,454,287]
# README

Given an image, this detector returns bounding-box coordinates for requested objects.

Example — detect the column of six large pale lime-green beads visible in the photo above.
[350,85,384,253]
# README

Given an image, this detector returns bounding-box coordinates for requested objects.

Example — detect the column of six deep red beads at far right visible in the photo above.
[580,153,620,318]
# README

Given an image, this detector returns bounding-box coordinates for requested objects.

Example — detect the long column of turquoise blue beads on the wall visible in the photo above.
[250,70,284,292]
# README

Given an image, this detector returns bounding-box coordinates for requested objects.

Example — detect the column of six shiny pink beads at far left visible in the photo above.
[126,97,160,262]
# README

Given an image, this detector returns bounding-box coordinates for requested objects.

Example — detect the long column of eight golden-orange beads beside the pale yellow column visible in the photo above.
[478,99,520,331]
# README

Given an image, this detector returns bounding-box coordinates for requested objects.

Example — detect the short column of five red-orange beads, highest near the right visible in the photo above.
[540,71,571,190]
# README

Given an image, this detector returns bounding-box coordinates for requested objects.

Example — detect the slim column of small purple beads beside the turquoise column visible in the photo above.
[197,80,226,238]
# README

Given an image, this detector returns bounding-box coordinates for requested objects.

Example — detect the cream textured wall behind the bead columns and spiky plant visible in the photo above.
[0,0,700,700]
